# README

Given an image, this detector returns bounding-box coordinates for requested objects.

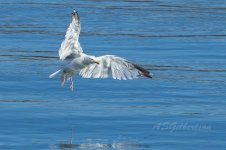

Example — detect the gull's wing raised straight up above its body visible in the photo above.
[59,11,83,60]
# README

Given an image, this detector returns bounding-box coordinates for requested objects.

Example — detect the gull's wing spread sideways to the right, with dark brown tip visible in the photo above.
[80,55,152,80]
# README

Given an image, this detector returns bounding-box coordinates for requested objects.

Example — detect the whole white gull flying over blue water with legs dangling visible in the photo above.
[49,11,152,91]
